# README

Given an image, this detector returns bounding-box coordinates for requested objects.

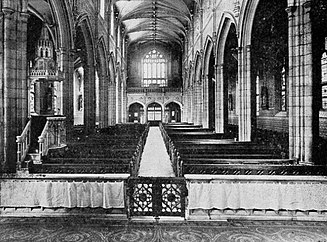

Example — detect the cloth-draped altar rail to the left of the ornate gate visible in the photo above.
[0,174,129,218]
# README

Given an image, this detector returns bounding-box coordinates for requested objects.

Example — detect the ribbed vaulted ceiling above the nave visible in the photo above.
[115,0,194,45]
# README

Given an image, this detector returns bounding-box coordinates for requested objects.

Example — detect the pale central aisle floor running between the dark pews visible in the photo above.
[139,127,175,177]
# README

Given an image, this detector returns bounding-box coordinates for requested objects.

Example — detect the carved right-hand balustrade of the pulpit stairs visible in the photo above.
[38,116,66,157]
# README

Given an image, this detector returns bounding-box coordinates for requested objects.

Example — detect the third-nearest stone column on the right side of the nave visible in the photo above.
[215,65,225,134]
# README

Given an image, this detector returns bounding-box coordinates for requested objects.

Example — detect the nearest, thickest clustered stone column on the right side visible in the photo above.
[286,1,314,164]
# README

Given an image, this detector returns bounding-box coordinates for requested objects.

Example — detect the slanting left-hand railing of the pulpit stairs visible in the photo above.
[16,120,31,170]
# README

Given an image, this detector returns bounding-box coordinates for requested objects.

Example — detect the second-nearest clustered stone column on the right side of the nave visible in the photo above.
[238,45,251,141]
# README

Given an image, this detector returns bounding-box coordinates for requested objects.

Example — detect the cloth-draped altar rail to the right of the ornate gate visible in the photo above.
[185,175,327,221]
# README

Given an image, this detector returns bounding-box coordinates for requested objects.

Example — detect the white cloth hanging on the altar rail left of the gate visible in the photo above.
[0,180,124,208]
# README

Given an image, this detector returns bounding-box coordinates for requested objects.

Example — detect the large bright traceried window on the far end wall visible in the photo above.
[142,49,167,87]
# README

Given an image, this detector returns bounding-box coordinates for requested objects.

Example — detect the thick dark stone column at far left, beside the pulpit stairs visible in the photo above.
[0,6,29,172]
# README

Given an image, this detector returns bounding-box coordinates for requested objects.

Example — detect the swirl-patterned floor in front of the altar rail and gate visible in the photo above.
[0,217,327,242]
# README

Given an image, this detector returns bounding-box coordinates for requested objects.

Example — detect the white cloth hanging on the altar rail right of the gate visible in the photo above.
[188,180,327,211]
